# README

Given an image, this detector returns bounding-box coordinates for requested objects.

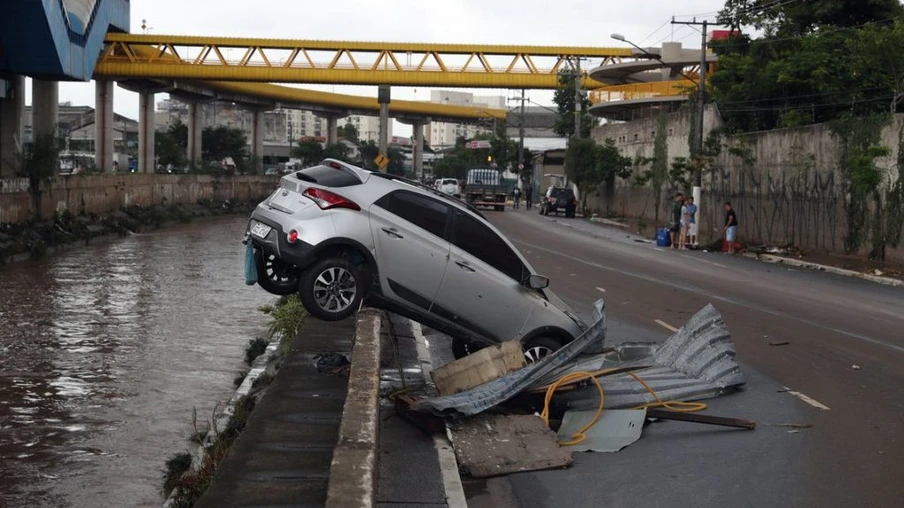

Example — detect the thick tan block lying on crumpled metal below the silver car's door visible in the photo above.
[431,340,525,395]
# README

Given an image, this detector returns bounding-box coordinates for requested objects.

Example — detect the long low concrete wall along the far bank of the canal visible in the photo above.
[0,173,279,223]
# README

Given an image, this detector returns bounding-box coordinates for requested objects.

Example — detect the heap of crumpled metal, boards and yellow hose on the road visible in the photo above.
[396,300,760,478]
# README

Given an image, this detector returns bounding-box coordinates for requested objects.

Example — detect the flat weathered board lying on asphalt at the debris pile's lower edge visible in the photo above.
[449,414,572,478]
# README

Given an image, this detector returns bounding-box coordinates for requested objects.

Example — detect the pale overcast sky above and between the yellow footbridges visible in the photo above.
[26,0,724,135]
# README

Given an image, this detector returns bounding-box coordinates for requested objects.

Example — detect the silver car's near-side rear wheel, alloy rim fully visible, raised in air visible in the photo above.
[298,257,365,321]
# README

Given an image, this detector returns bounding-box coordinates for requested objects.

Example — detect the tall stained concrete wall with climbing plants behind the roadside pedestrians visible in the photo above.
[590,104,904,259]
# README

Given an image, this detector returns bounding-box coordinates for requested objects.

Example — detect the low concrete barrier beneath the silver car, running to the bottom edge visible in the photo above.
[326,309,383,508]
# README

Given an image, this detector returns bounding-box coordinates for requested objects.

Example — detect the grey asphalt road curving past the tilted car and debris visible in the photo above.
[456,209,904,508]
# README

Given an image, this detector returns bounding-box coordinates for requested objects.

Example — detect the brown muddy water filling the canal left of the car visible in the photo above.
[0,217,275,507]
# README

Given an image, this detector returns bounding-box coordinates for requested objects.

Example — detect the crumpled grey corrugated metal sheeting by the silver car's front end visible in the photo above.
[416,300,745,416]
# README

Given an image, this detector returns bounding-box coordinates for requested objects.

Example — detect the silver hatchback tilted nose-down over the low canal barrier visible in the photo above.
[245,159,586,360]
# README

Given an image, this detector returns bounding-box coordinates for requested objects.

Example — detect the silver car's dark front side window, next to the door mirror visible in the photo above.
[452,210,527,284]
